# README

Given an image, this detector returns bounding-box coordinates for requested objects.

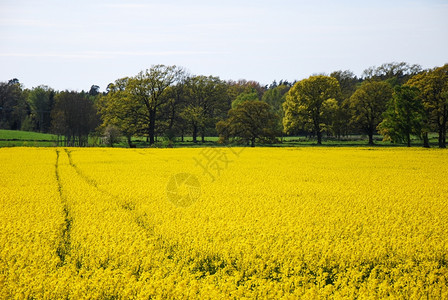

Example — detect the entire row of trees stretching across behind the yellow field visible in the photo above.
[0,63,448,148]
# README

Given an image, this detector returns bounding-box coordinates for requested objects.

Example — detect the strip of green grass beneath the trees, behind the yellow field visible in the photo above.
[0,129,437,148]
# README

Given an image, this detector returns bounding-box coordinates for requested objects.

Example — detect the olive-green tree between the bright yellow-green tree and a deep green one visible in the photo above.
[349,81,393,145]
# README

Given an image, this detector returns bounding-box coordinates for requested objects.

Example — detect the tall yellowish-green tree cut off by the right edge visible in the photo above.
[407,64,448,148]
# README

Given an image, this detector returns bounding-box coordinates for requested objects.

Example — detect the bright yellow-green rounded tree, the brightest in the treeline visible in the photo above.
[283,75,341,144]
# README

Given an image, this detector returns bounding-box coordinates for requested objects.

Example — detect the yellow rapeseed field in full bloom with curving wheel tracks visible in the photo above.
[0,148,448,299]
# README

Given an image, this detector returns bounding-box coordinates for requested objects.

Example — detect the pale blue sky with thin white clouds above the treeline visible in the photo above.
[0,0,448,91]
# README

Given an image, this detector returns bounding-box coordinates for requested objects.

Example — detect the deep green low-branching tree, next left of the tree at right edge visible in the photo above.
[378,85,425,147]
